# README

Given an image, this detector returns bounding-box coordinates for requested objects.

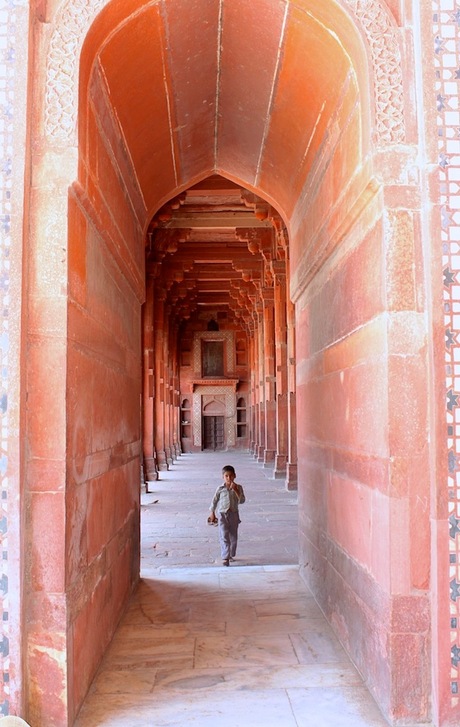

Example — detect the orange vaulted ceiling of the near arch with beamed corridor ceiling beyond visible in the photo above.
[81,0,365,328]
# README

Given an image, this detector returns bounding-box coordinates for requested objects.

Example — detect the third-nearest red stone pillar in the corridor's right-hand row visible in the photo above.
[261,286,276,467]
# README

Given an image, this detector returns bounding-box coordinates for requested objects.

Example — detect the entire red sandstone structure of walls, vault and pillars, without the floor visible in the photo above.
[0,0,460,727]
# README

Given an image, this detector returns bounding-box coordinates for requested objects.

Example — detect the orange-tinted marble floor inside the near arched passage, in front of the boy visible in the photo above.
[77,565,398,727]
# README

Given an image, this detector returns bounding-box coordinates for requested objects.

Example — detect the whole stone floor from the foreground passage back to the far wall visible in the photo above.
[76,453,418,727]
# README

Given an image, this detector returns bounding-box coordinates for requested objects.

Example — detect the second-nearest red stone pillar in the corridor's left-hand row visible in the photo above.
[154,286,168,471]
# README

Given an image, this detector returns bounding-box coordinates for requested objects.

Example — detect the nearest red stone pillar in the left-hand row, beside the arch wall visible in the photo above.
[142,275,158,492]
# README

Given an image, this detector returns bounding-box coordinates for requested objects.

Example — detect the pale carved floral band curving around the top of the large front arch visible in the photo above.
[45,0,405,146]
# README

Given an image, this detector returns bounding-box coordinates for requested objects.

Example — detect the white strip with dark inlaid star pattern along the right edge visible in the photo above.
[433,0,460,707]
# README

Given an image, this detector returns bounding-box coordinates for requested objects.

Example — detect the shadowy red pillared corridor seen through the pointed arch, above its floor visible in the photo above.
[143,174,297,472]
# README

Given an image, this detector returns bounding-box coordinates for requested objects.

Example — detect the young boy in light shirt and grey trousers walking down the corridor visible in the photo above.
[209,465,246,565]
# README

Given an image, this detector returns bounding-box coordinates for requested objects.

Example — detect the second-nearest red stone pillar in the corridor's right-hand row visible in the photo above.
[272,261,289,477]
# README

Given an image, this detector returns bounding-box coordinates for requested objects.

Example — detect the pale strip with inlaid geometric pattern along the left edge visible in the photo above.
[0,0,28,716]
